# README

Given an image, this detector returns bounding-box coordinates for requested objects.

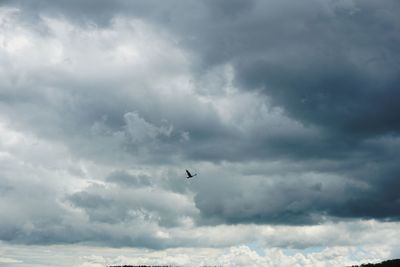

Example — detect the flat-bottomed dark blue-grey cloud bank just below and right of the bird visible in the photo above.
[195,157,400,224]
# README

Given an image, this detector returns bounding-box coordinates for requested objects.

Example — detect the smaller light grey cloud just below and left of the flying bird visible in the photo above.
[69,177,196,227]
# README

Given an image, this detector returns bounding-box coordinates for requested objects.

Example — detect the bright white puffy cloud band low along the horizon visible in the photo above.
[0,244,390,267]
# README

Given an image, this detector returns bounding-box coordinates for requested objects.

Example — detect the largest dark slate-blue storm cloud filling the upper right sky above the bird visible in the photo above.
[7,0,400,156]
